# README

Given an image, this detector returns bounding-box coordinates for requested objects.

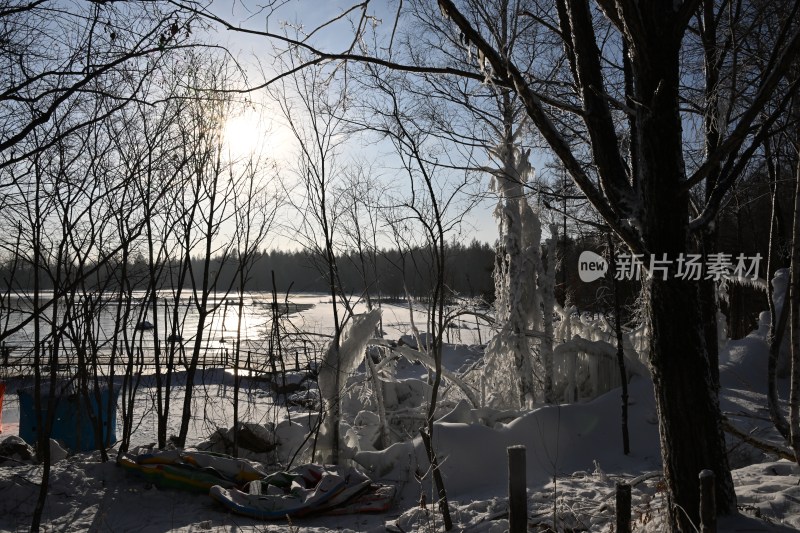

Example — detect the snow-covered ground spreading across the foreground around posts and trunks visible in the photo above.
[0,300,800,532]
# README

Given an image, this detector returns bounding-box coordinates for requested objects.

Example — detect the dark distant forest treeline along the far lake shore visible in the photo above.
[0,240,495,301]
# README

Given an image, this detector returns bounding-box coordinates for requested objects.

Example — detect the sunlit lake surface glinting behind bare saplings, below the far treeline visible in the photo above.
[0,292,488,372]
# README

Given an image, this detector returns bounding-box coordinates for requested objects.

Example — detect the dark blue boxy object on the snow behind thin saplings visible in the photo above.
[17,387,119,452]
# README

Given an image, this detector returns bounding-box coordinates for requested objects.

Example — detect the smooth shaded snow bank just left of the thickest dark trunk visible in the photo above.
[354,378,660,498]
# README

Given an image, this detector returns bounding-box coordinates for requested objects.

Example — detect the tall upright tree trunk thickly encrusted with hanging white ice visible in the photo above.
[483,109,555,408]
